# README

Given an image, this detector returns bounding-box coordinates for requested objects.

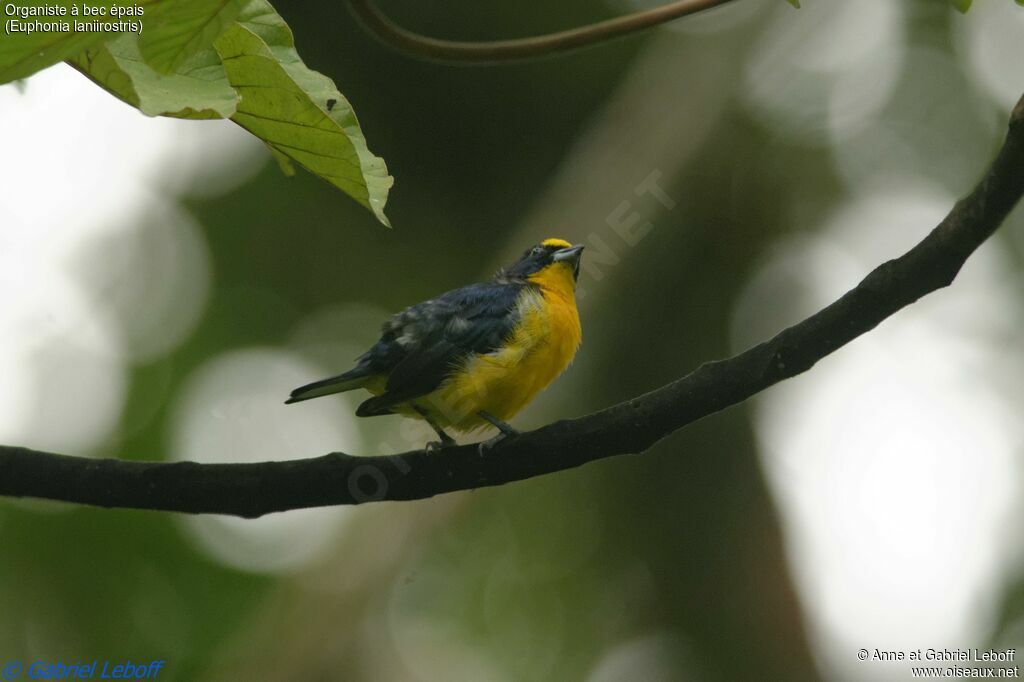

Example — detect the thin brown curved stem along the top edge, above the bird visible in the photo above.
[349,0,731,65]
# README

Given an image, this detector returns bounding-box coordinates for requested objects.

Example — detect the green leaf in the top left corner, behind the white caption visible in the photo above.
[0,0,154,84]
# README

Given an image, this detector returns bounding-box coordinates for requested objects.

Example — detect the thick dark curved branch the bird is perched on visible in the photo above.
[6,97,1024,517]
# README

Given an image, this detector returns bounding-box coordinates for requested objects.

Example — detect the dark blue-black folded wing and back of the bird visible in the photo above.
[356,282,529,417]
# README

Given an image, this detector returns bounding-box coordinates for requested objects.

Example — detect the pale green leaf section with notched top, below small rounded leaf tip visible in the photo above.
[71,35,238,119]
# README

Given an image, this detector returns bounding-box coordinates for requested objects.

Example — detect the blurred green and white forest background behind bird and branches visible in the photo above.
[0,0,1024,682]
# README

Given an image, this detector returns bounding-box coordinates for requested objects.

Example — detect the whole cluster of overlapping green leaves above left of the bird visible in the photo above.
[18,0,393,225]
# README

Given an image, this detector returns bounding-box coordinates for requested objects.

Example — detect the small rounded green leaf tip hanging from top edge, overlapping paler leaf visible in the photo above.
[138,0,242,74]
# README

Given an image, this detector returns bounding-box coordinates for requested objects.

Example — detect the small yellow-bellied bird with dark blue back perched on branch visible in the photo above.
[285,239,584,454]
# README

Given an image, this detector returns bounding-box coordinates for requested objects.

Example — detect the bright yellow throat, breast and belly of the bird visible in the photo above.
[426,263,582,431]
